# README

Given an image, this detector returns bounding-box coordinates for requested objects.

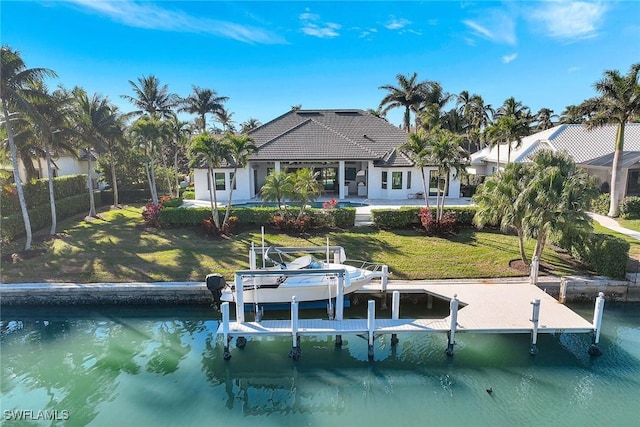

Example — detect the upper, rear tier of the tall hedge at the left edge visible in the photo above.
[0,175,87,217]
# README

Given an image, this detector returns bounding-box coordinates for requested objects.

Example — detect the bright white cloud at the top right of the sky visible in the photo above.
[529,1,607,41]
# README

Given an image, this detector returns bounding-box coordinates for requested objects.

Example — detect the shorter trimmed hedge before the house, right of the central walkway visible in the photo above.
[371,206,476,230]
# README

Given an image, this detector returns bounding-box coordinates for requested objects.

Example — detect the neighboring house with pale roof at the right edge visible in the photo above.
[467,123,640,202]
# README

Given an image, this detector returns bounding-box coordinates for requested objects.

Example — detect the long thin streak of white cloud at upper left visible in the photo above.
[68,0,285,44]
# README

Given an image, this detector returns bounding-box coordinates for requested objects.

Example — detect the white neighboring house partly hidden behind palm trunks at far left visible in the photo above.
[2,149,99,188]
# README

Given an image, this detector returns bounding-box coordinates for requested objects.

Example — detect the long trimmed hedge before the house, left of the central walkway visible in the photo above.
[158,207,356,228]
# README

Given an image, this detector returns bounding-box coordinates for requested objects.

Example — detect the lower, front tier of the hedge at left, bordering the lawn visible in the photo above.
[0,191,102,243]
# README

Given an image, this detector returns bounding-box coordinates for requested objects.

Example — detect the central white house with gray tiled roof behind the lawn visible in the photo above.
[194,110,460,203]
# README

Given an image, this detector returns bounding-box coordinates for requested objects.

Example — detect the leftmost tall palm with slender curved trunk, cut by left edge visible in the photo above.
[0,46,56,251]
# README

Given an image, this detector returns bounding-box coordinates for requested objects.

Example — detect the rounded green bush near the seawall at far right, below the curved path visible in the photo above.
[571,234,630,278]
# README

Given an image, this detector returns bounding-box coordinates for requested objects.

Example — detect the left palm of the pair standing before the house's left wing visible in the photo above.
[189,132,228,230]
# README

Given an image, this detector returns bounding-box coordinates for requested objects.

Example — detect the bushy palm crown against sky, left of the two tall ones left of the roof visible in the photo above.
[122,75,176,119]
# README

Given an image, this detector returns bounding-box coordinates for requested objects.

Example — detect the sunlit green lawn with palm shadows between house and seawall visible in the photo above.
[2,206,573,283]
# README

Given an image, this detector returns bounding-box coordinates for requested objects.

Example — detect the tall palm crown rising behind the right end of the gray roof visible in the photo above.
[379,73,431,132]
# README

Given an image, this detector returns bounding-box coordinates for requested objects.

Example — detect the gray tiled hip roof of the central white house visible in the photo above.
[249,110,411,166]
